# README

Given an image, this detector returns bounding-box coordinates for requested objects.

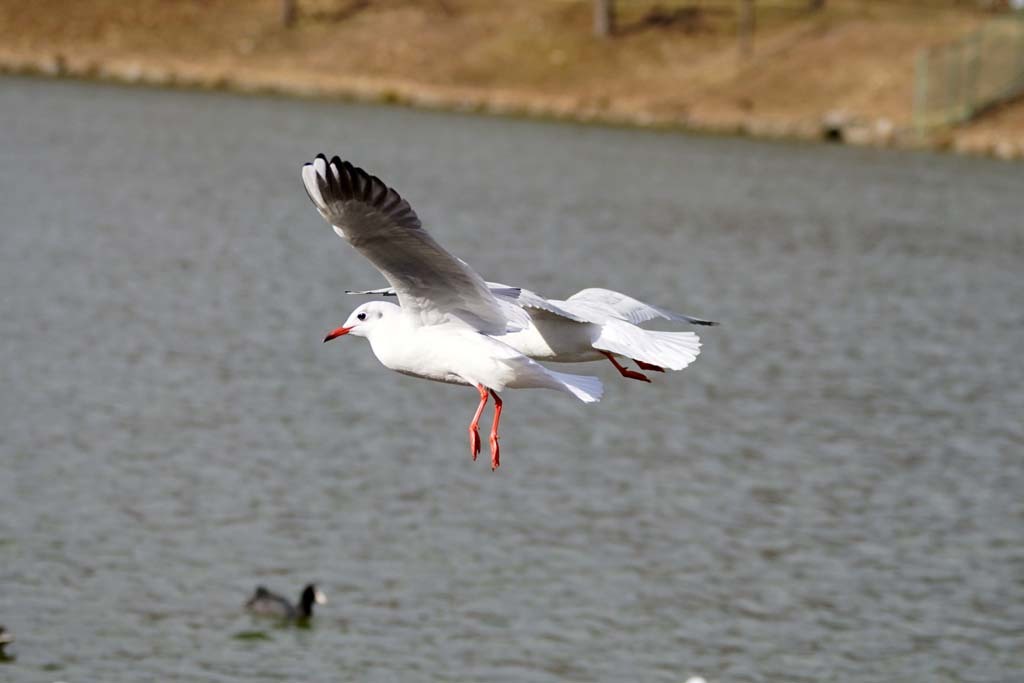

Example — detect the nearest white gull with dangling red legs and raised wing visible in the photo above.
[302,155,602,468]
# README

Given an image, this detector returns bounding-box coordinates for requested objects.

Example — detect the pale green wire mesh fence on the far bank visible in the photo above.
[913,15,1024,129]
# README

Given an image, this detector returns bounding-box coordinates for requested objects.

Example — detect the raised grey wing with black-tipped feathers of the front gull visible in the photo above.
[302,155,522,334]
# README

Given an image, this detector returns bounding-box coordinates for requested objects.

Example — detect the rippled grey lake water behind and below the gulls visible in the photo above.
[0,78,1024,683]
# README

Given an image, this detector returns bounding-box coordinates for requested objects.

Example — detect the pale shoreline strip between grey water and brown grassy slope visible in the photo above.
[0,7,1024,160]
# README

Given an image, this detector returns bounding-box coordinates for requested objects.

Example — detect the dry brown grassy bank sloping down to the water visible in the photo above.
[0,0,1024,158]
